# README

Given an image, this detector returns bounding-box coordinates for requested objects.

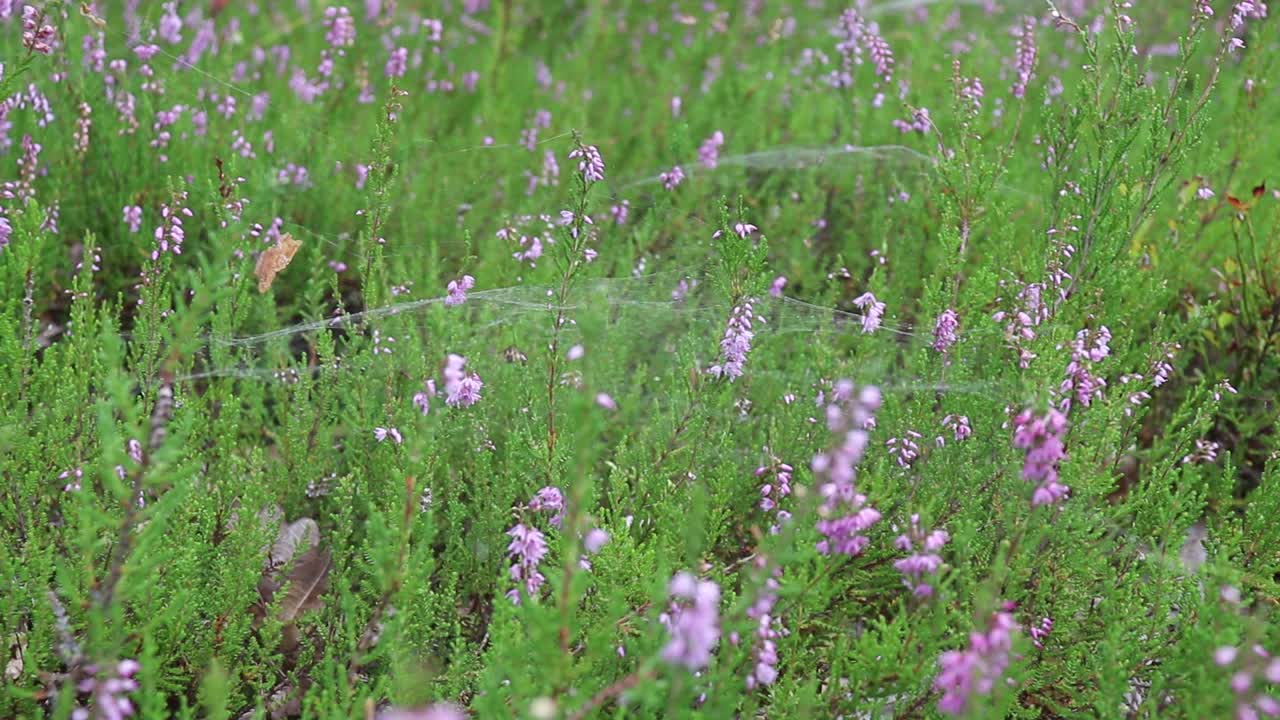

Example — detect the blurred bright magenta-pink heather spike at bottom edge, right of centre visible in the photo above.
[933,611,1018,715]
